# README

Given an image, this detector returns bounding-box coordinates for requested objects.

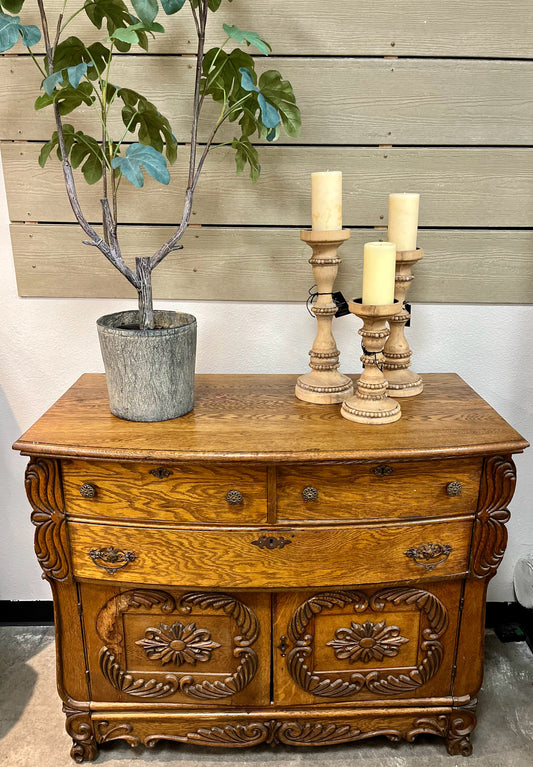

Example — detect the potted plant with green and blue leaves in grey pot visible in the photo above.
[0,0,300,421]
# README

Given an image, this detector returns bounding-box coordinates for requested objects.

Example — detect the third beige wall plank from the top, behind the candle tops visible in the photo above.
[2,143,533,228]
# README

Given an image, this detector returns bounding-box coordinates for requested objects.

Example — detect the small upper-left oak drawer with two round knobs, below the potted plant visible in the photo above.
[62,460,267,524]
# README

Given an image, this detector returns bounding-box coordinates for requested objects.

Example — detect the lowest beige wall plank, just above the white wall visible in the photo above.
[11,223,533,303]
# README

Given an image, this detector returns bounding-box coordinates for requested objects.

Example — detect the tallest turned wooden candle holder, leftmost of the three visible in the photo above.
[294,229,353,405]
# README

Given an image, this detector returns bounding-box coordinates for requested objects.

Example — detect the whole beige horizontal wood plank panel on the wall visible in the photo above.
[0,0,533,303]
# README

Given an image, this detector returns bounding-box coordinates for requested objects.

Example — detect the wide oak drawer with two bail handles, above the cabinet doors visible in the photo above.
[68,517,472,589]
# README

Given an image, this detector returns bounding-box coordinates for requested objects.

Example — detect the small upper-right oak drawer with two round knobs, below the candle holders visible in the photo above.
[277,458,482,521]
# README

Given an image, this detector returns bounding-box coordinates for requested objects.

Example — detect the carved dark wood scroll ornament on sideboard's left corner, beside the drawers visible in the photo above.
[25,458,69,581]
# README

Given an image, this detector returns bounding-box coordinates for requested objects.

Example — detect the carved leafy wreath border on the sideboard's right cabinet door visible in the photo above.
[287,588,448,698]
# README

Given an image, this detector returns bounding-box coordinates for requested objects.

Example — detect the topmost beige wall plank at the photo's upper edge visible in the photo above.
[16,0,533,58]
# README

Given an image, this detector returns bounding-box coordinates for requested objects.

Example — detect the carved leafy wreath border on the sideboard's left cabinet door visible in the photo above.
[96,589,259,700]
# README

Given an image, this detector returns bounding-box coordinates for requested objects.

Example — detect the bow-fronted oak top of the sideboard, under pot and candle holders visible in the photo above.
[13,373,528,462]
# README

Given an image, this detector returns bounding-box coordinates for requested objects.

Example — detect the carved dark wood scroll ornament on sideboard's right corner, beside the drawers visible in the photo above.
[472,456,516,578]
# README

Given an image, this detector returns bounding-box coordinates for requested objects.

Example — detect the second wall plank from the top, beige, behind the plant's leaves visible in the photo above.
[0,56,533,146]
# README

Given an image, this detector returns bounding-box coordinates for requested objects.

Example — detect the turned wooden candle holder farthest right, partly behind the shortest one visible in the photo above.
[383,248,424,397]
